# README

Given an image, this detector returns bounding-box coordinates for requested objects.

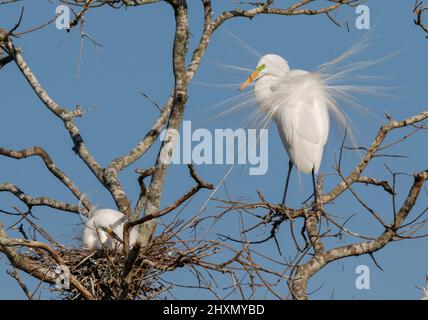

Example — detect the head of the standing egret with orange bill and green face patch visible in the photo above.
[239,54,290,91]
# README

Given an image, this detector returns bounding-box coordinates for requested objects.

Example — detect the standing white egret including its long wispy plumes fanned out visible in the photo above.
[197,32,392,210]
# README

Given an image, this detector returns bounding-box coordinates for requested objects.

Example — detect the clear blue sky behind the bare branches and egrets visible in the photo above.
[0,0,428,299]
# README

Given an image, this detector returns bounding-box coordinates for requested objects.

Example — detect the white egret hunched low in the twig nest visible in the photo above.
[83,209,138,250]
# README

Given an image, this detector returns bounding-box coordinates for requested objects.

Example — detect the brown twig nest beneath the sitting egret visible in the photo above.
[31,230,181,300]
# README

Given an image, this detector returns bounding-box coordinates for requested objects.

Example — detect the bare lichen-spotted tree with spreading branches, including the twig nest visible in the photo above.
[0,0,428,299]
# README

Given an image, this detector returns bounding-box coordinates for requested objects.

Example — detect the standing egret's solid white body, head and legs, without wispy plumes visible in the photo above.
[239,54,335,205]
